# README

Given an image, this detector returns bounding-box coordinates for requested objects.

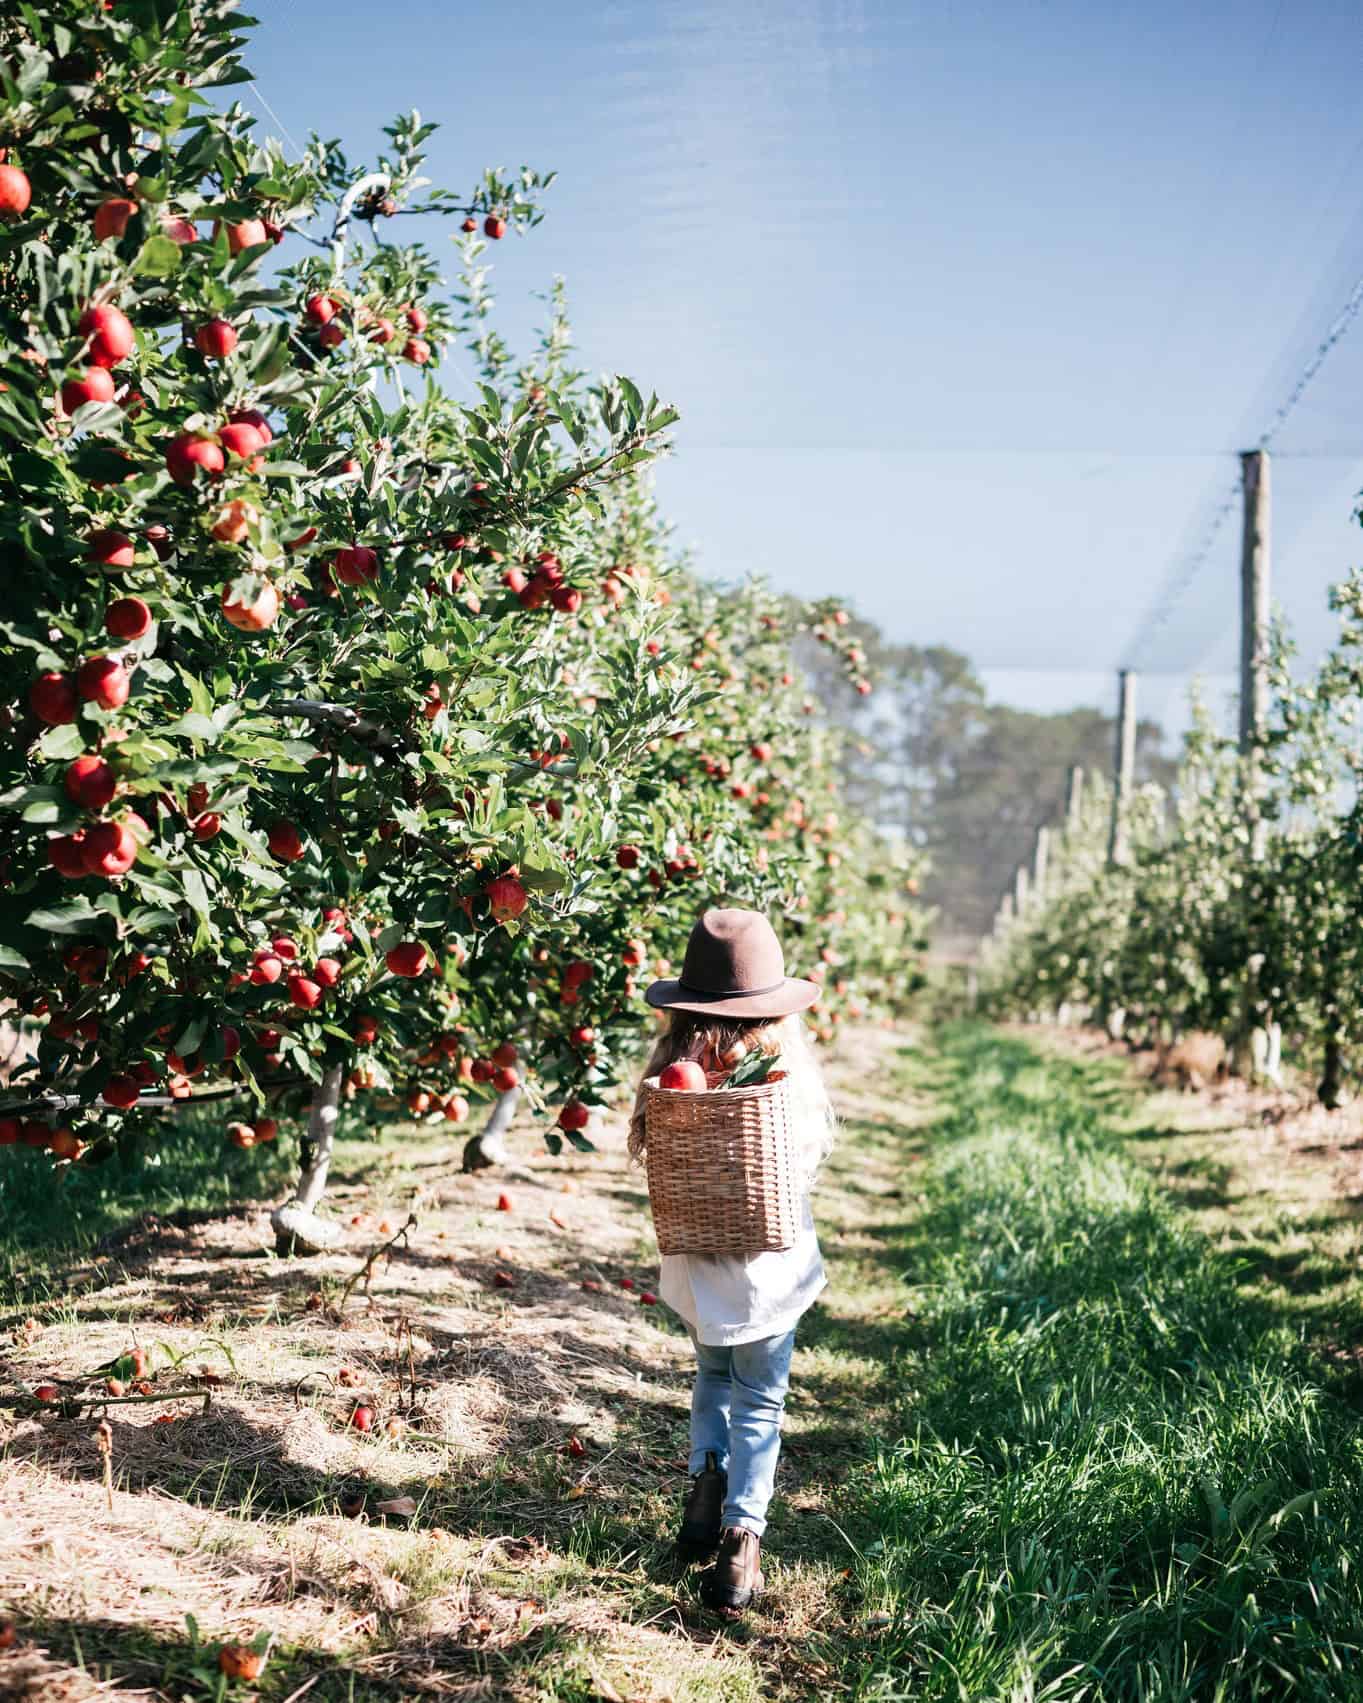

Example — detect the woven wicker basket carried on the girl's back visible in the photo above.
[644,1073,804,1253]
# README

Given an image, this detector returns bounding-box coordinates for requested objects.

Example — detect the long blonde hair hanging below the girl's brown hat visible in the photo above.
[629,1012,837,1180]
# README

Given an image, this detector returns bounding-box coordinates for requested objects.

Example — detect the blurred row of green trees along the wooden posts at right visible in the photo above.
[990,541,1363,1105]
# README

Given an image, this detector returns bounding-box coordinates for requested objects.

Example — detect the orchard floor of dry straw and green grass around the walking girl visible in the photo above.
[0,1027,1363,1703]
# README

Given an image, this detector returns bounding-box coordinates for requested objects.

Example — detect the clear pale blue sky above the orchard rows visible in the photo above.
[247,0,1363,739]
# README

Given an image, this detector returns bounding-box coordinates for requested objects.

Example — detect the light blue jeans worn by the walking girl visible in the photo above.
[690,1330,796,1538]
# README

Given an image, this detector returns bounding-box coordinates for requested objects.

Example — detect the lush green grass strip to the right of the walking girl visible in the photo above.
[855,1029,1363,1703]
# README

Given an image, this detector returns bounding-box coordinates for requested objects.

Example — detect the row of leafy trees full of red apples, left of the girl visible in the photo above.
[0,0,918,1240]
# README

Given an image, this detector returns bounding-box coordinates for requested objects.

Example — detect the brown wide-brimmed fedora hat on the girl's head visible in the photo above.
[644,911,820,1017]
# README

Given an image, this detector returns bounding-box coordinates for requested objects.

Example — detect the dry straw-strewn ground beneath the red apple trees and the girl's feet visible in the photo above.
[0,1032,912,1703]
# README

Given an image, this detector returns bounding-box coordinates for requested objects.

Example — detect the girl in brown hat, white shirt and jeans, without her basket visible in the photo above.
[629,911,833,1614]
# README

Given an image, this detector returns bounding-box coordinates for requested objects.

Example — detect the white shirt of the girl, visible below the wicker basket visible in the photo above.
[658,1196,828,1347]
